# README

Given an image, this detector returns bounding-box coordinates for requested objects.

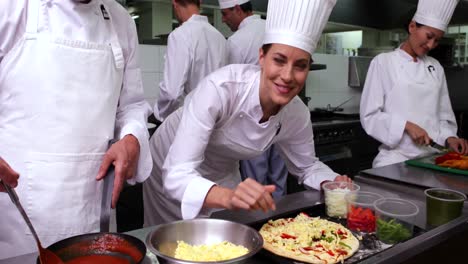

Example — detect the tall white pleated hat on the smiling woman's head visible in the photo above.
[263,0,336,54]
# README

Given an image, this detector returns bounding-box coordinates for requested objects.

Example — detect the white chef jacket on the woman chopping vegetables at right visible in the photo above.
[360,48,457,167]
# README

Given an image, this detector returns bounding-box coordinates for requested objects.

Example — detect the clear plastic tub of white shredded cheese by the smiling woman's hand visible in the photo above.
[322,182,360,218]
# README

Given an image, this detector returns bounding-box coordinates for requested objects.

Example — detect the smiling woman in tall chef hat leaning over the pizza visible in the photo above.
[144,0,350,226]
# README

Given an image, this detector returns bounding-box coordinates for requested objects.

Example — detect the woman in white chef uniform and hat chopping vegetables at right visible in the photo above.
[360,0,468,167]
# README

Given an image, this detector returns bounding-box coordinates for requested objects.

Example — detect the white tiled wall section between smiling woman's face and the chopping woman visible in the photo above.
[306,54,361,111]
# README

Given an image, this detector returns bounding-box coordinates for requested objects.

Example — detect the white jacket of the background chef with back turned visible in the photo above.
[154,15,227,121]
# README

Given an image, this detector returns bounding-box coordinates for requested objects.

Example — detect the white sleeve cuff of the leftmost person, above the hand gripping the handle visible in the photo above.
[119,122,153,185]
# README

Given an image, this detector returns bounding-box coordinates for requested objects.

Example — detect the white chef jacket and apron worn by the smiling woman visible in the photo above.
[143,64,337,226]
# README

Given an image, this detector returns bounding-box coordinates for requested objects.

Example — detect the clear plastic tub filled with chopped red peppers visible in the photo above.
[345,191,383,233]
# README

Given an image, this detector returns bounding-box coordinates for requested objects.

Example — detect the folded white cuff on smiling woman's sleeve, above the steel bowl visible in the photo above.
[181,177,215,219]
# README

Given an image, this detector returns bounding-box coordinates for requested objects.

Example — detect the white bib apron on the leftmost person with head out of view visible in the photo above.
[0,0,124,259]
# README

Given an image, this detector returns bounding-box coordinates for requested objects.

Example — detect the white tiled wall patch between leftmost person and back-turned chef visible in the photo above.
[138,45,166,107]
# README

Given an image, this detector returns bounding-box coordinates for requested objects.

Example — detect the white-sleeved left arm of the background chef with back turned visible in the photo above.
[154,32,192,121]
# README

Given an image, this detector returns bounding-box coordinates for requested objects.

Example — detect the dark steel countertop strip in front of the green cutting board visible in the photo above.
[361,163,468,194]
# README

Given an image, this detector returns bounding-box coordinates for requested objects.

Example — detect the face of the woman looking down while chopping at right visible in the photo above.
[408,21,444,57]
